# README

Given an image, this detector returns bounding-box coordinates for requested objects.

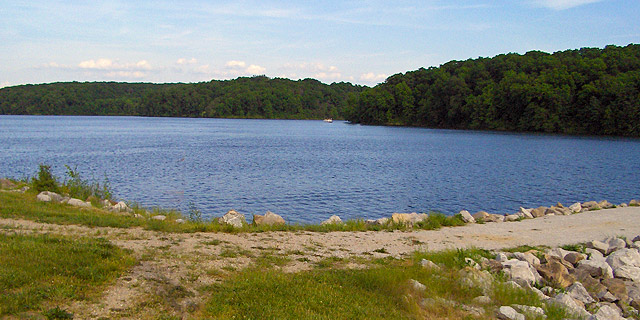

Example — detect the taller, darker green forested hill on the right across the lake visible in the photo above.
[346,44,640,136]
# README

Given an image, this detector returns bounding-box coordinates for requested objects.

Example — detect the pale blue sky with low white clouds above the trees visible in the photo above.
[0,0,640,87]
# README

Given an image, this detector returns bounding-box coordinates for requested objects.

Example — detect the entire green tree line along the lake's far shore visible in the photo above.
[0,44,640,136]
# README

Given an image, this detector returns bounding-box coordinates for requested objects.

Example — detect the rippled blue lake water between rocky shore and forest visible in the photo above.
[0,116,640,222]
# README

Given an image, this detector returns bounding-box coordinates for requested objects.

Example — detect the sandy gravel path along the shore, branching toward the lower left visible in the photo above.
[0,207,640,319]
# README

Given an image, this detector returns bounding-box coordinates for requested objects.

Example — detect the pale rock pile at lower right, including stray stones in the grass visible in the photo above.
[416,236,640,320]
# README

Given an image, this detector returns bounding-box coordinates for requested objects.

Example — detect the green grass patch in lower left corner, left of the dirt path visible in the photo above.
[0,234,135,316]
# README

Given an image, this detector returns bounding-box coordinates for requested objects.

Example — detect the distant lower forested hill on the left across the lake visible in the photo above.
[0,76,363,119]
